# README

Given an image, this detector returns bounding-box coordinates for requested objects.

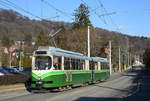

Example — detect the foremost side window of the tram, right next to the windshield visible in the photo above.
[53,56,61,70]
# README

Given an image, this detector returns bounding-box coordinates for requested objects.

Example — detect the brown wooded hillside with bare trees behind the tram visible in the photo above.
[0,9,150,65]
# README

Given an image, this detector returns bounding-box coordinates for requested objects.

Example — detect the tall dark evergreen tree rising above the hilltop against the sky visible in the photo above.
[73,3,91,28]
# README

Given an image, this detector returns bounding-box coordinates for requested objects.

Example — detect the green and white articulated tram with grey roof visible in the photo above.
[31,46,110,89]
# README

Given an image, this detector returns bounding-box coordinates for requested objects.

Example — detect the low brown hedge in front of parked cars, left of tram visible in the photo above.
[0,74,31,85]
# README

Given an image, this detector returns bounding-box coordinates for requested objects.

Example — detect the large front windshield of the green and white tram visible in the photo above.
[34,56,52,70]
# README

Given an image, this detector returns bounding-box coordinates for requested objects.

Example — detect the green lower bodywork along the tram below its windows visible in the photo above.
[32,70,109,88]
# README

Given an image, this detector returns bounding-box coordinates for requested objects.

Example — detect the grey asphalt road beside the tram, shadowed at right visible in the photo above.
[0,66,150,101]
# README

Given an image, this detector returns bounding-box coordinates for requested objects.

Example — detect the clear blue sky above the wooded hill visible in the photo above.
[0,0,150,37]
